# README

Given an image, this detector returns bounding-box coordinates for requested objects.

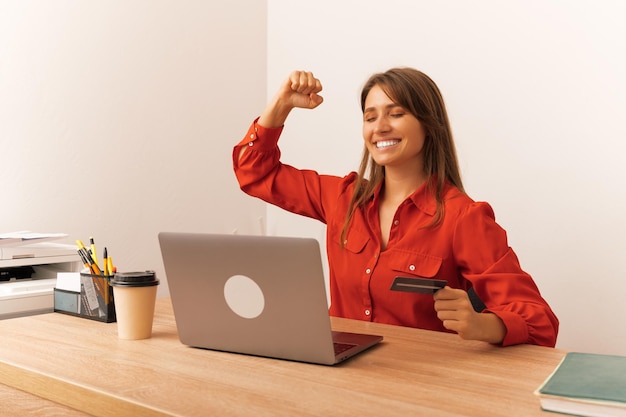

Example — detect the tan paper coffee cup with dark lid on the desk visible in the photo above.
[111,271,159,340]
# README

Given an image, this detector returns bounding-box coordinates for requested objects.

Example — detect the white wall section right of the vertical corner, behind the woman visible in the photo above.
[266,0,626,354]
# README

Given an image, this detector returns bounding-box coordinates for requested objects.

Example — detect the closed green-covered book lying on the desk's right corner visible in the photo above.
[535,352,626,417]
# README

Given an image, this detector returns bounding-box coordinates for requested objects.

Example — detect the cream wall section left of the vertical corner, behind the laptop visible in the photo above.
[0,0,267,295]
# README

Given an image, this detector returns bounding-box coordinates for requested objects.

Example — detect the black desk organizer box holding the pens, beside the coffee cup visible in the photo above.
[54,272,116,323]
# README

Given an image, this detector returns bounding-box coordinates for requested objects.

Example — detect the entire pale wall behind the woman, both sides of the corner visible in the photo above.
[0,0,626,354]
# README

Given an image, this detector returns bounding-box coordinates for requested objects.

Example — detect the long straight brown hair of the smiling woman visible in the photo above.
[341,68,464,245]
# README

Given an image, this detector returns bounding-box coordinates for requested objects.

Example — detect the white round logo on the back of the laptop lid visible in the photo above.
[224,275,265,319]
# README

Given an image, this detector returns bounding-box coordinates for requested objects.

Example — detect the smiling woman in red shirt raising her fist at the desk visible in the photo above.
[233,68,558,346]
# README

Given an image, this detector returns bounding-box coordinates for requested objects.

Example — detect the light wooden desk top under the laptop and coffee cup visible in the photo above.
[0,298,565,417]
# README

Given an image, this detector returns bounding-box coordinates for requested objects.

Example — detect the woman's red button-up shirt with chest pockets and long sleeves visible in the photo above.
[233,121,558,346]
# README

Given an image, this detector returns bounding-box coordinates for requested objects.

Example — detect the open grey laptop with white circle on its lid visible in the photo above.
[159,232,382,365]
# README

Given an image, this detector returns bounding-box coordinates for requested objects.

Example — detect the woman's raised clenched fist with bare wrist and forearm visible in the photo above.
[258,71,324,128]
